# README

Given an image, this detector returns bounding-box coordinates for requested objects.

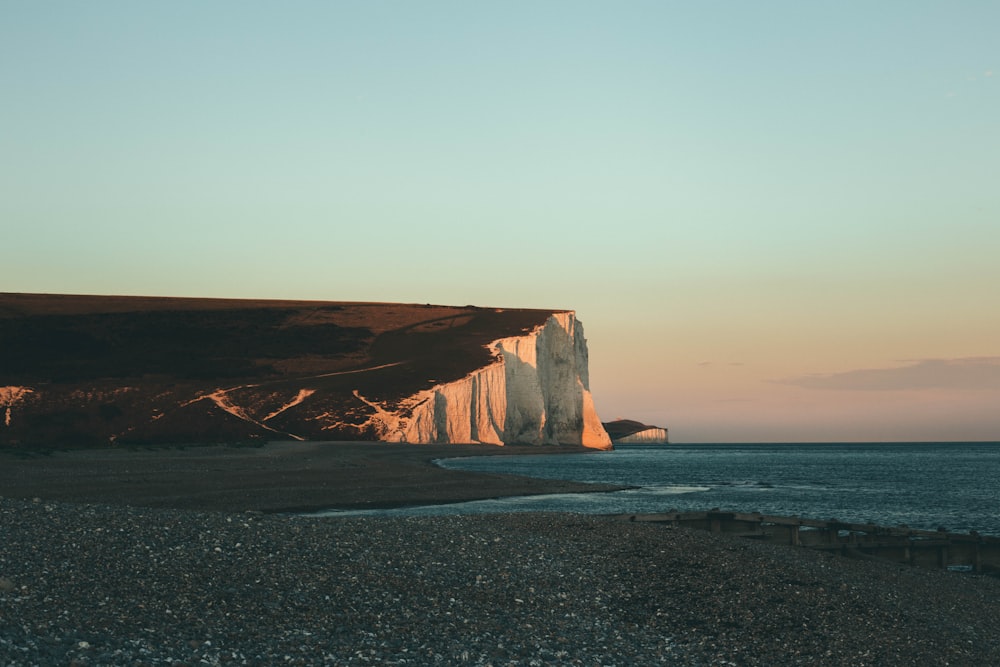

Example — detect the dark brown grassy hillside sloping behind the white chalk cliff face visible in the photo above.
[0,294,555,445]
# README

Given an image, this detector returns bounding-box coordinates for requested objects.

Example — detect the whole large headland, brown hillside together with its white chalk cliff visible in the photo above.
[0,294,611,448]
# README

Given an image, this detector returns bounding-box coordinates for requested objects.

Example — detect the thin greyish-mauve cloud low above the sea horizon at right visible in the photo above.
[777,357,1000,391]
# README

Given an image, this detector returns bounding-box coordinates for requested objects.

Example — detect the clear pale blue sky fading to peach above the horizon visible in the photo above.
[0,5,1000,442]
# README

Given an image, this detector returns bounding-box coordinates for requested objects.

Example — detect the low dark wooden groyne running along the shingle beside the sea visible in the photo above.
[620,510,1000,576]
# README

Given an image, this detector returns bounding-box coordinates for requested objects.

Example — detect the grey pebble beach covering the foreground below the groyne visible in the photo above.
[0,498,1000,666]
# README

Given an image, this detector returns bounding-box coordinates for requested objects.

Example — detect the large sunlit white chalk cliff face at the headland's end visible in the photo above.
[356,311,612,449]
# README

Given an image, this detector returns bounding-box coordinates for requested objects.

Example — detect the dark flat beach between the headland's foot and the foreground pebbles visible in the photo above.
[0,442,620,512]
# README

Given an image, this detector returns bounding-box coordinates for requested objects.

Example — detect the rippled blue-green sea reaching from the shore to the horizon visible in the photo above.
[312,442,1000,536]
